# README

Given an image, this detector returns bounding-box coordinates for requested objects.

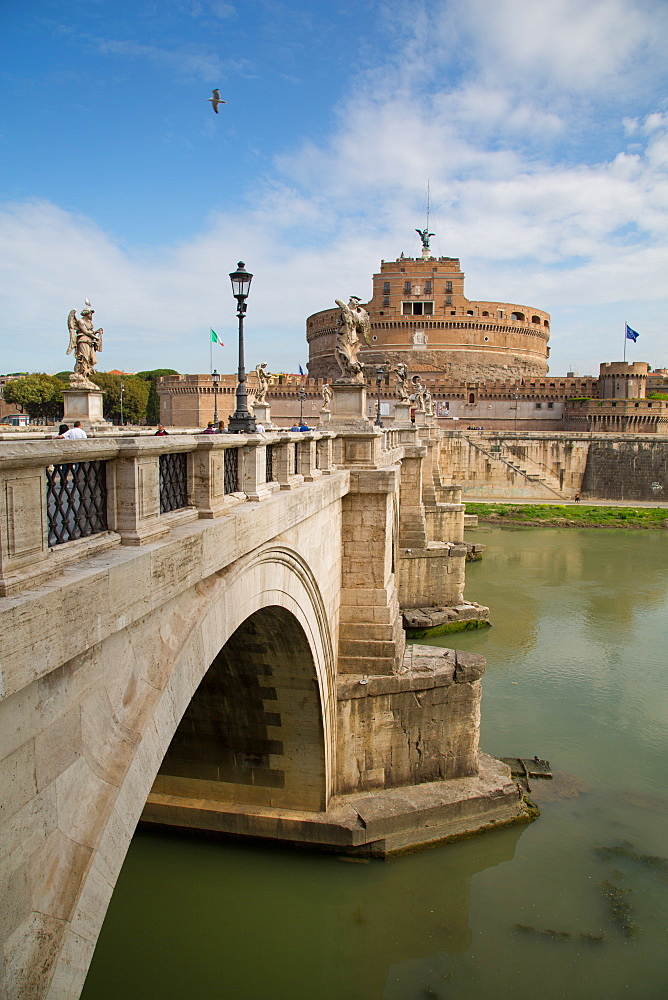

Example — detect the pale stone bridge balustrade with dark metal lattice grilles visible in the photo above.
[0,431,336,596]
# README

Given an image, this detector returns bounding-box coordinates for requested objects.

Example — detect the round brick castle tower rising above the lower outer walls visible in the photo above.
[306,247,550,381]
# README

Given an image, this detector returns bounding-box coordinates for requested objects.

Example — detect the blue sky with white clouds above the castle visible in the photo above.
[0,0,668,374]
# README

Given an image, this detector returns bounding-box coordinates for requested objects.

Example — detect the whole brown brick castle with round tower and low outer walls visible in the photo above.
[158,238,668,434]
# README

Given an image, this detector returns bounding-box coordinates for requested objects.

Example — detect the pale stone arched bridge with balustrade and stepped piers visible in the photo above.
[0,408,526,1000]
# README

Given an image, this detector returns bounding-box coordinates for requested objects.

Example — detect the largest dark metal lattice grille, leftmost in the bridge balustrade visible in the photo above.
[46,461,107,548]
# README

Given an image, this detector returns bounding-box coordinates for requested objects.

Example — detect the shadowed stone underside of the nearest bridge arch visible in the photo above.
[151,605,327,819]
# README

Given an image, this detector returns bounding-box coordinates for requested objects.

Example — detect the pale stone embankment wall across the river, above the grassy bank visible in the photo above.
[441,431,668,501]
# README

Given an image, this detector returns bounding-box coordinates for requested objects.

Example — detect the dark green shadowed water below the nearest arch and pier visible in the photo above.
[82,827,524,1000]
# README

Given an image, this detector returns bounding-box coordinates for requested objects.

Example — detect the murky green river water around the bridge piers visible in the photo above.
[83,528,668,1000]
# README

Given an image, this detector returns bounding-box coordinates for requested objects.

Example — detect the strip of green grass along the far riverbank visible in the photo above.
[465,500,668,528]
